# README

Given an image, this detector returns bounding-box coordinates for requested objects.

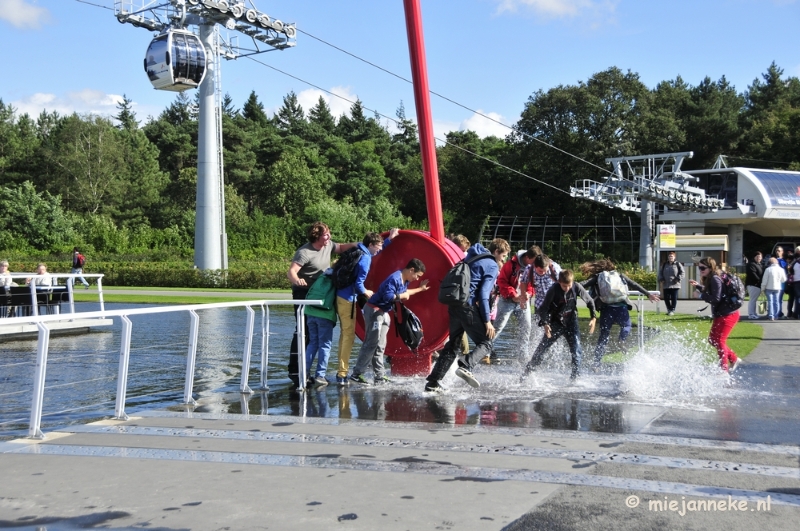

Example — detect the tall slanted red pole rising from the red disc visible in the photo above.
[403,0,445,243]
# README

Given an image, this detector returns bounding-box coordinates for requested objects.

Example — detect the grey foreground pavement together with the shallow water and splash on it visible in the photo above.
[0,301,800,531]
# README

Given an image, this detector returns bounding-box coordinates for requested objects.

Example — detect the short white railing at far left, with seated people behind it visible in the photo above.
[0,272,105,322]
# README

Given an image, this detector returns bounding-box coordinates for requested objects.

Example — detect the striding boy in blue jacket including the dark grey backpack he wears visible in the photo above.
[425,238,511,393]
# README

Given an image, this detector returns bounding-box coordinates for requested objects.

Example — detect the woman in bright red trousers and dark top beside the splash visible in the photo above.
[689,258,744,372]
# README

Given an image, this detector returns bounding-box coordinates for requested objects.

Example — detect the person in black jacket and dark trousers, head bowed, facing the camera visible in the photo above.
[522,269,597,380]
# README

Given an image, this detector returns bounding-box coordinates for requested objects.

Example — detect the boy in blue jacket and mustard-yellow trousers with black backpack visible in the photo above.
[333,228,400,386]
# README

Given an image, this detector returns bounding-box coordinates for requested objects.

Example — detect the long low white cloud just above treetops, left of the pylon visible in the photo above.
[10,89,163,123]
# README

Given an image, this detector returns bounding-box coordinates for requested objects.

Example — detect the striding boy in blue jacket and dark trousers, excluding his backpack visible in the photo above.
[425,238,510,393]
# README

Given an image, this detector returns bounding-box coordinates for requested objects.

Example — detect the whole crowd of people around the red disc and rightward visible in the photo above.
[276,222,788,392]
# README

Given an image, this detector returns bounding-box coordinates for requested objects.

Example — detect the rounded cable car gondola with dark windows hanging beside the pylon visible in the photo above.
[144,28,206,92]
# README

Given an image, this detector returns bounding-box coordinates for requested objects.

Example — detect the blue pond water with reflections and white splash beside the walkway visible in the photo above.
[0,304,800,441]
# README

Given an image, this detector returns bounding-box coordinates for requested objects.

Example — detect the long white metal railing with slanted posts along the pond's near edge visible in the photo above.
[3,300,323,439]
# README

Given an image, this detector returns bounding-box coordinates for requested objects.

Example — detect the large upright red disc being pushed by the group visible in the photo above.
[356,230,464,376]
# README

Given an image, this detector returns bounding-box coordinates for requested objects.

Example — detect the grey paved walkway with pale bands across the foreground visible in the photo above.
[0,292,800,531]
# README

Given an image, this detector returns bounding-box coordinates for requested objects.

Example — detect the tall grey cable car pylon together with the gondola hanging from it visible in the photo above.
[114,0,297,270]
